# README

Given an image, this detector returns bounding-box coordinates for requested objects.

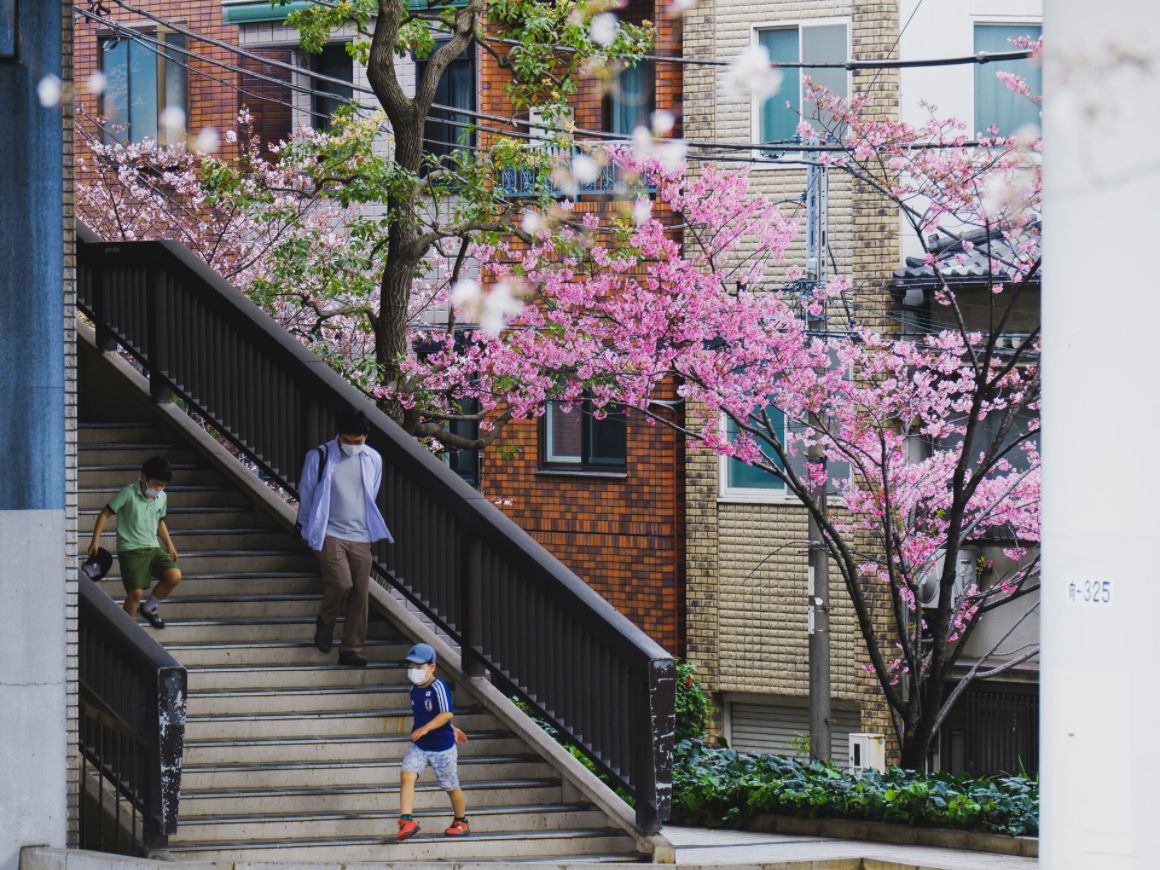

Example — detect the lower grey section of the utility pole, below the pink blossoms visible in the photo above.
[807,447,832,761]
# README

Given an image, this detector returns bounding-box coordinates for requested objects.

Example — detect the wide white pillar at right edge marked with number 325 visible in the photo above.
[1041,0,1160,870]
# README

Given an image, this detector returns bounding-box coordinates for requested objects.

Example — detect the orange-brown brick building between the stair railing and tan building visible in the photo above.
[479,0,686,654]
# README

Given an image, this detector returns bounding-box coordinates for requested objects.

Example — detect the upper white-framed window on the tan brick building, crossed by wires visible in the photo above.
[755,21,850,143]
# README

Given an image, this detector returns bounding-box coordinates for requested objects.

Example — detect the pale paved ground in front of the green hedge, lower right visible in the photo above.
[664,825,1039,870]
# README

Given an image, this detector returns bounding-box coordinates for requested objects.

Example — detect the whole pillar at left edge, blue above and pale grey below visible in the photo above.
[0,0,68,870]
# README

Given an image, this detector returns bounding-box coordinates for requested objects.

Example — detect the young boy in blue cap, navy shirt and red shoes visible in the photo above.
[398,644,471,842]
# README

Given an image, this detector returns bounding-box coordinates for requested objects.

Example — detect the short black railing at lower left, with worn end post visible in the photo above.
[79,574,186,855]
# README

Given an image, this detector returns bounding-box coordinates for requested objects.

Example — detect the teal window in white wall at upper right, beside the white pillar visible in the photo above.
[974,24,1043,136]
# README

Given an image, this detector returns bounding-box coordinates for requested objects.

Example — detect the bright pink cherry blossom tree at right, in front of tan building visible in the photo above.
[419,93,1039,767]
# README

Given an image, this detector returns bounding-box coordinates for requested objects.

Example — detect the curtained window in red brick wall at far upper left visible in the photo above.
[100,31,188,145]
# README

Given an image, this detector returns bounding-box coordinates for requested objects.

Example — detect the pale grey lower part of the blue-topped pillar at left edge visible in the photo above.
[0,510,71,870]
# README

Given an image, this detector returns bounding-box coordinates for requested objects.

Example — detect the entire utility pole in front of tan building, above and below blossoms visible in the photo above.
[806,158,832,761]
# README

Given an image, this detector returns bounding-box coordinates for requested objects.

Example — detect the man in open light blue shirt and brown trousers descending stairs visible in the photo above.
[298,409,394,667]
